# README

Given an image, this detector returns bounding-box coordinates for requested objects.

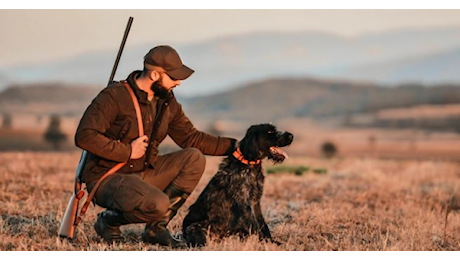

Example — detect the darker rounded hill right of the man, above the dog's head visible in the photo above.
[187,78,460,121]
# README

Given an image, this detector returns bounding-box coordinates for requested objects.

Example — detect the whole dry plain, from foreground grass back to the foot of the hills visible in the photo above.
[0,112,460,251]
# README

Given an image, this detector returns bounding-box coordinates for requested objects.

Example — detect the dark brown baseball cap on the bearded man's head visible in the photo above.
[144,45,195,80]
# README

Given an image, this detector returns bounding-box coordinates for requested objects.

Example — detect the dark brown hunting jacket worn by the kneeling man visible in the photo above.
[75,71,236,183]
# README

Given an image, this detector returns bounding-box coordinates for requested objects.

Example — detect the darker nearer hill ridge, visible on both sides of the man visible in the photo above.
[0,78,460,121]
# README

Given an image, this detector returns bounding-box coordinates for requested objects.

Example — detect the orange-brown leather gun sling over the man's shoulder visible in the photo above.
[74,82,144,226]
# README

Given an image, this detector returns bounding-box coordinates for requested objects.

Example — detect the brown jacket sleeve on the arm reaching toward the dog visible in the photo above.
[168,98,236,156]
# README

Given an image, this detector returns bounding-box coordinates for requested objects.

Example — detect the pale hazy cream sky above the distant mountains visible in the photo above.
[0,9,460,67]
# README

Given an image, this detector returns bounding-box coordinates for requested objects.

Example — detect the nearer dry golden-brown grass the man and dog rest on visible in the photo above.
[0,151,460,251]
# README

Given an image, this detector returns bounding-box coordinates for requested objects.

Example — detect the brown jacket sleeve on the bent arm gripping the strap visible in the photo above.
[75,88,131,162]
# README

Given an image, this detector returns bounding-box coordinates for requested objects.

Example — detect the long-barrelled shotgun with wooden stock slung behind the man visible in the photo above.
[59,17,134,239]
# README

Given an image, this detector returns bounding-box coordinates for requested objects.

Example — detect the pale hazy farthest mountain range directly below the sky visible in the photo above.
[0,28,460,97]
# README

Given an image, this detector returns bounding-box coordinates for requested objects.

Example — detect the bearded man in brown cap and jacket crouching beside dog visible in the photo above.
[75,45,236,247]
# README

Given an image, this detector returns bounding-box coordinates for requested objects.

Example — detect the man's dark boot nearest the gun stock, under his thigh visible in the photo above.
[94,209,129,243]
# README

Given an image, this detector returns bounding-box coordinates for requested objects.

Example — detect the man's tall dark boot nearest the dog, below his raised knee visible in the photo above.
[142,184,190,248]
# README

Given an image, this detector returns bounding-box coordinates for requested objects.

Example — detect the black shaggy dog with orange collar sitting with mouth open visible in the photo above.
[182,124,294,246]
